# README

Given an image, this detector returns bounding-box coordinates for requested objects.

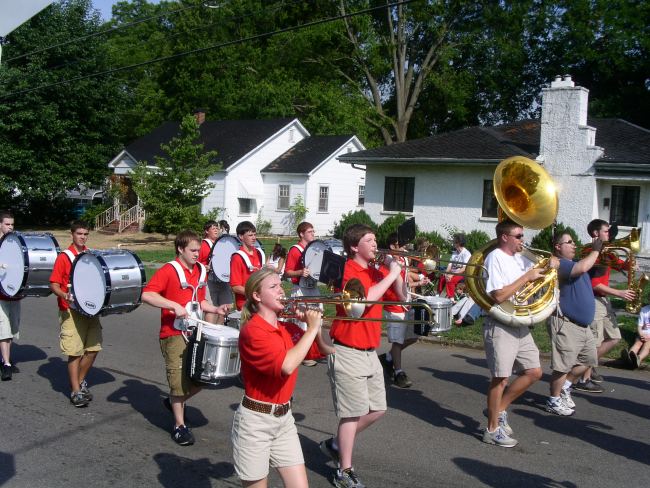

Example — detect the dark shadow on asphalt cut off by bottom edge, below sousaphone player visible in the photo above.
[452,458,577,488]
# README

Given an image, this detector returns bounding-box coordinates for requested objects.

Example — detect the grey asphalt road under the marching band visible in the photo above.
[0,297,650,488]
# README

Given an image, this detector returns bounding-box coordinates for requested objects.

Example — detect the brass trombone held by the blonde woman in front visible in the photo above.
[279,278,435,325]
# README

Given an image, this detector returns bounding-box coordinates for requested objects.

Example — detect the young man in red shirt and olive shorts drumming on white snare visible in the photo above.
[142,230,229,446]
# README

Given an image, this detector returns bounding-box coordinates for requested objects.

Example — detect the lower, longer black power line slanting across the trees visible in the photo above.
[0,0,419,100]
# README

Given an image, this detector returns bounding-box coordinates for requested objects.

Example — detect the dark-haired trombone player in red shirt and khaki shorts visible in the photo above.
[320,224,404,487]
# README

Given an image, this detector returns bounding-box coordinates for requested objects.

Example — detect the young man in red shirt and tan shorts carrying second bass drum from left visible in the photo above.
[50,220,102,407]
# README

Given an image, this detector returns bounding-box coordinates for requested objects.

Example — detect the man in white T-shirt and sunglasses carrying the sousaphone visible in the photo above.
[483,220,559,447]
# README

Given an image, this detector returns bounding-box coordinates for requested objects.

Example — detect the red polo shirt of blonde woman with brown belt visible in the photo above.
[239,314,298,403]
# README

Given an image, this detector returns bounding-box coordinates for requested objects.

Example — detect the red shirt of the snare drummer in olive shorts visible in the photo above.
[142,258,205,339]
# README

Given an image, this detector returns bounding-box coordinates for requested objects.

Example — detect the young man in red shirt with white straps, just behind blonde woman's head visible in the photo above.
[230,220,263,310]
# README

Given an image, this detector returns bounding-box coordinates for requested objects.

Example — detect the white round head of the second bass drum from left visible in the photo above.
[70,252,110,317]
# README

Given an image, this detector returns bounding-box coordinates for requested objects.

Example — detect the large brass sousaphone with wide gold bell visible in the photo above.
[465,156,559,327]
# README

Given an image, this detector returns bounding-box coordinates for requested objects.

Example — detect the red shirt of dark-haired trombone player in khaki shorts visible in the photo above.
[330,259,386,349]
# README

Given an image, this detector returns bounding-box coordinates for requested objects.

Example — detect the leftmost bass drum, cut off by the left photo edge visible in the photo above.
[0,232,60,297]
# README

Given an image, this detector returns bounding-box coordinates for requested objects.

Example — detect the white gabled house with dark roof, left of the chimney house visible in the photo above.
[108,112,365,235]
